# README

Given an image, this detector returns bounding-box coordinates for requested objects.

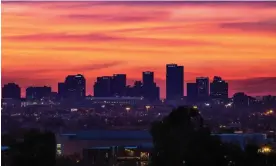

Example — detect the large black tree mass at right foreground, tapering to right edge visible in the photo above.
[150,107,276,166]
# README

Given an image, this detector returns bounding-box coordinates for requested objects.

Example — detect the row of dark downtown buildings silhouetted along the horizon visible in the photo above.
[2,64,264,101]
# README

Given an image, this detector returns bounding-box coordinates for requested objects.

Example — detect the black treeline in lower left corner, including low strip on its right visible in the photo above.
[1,129,81,166]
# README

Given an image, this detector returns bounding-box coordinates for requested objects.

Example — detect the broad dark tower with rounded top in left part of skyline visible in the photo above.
[64,74,86,99]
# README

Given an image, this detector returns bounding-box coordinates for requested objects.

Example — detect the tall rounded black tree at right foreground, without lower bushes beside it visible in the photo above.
[151,107,232,166]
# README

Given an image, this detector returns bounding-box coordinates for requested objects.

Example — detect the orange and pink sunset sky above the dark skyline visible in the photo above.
[2,2,276,97]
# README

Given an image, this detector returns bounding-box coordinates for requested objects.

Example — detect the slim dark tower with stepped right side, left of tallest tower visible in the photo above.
[143,71,160,101]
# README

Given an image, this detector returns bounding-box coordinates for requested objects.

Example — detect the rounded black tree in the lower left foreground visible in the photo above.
[10,130,56,166]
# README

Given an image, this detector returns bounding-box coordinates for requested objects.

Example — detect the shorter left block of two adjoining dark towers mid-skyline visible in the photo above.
[94,76,112,97]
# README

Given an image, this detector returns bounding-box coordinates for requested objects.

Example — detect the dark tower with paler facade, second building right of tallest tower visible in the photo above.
[196,77,209,101]
